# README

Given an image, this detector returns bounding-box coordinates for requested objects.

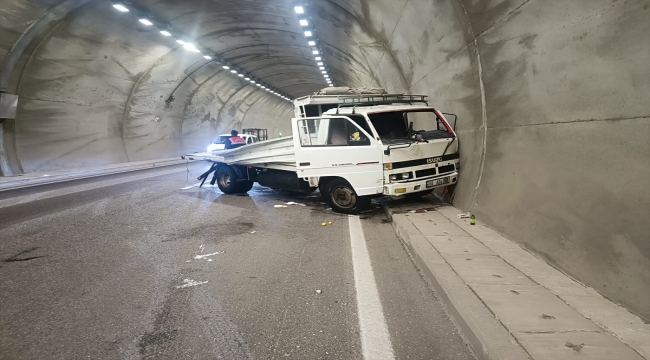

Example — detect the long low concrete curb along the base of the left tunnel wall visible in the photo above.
[0,158,197,192]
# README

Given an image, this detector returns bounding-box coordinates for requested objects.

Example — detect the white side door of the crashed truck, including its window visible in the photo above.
[292,116,383,196]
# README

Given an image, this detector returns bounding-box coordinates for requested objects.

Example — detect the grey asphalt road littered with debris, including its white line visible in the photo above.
[0,163,473,360]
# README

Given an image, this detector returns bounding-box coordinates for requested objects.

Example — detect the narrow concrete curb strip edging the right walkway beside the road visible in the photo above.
[393,214,531,360]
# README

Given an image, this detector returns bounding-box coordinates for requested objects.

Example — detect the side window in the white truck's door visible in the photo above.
[298,118,370,146]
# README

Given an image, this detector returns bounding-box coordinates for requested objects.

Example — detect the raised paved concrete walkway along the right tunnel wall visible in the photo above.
[391,198,650,360]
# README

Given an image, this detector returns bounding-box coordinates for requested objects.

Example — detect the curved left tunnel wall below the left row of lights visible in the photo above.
[0,1,293,173]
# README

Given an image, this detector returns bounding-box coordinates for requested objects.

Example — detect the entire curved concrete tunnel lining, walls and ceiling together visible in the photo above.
[0,0,650,319]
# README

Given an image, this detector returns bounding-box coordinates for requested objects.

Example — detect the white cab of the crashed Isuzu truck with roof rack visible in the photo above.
[293,94,460,205]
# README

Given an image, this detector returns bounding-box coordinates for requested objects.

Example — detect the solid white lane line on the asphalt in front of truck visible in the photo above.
[348,216,395,360]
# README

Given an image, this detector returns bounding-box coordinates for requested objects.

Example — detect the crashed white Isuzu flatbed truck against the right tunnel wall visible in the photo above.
[183,94,460,214]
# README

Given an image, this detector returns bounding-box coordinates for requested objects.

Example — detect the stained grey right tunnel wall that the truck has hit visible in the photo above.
[326,0,650,319]
